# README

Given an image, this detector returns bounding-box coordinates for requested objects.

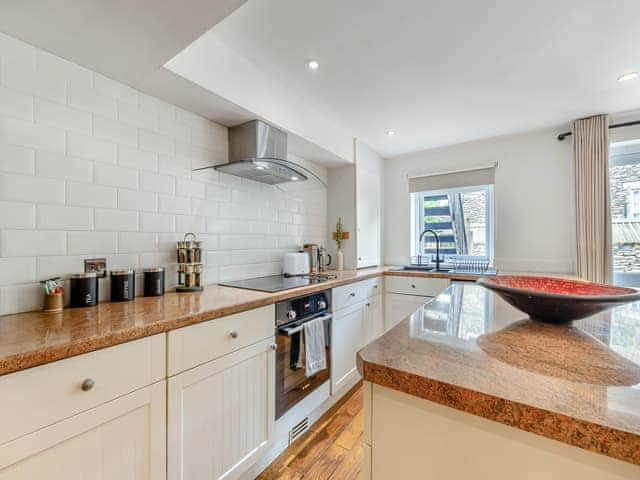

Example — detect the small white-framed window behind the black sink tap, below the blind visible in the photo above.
[413,185,493,264]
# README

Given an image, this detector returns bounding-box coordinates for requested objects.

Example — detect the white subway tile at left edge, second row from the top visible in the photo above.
[0,61,67,103]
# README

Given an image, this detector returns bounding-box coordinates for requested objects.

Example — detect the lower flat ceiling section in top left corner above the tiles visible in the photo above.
[0,0,246,86]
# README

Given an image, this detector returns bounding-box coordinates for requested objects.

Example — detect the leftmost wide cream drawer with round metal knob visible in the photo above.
[0,334,165,444]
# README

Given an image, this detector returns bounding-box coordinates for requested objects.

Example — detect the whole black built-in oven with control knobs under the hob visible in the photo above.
[275,290,331,419]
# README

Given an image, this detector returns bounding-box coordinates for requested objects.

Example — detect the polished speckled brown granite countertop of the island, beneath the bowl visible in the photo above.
[358,284,640,465]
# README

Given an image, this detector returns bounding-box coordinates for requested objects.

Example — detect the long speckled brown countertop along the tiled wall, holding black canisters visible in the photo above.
[0,267,496,375]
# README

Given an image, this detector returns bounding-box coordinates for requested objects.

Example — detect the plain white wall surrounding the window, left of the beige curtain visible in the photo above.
[384,129,575,272]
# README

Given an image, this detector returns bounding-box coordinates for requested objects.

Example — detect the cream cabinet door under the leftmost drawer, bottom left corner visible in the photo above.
[0,380,166,480]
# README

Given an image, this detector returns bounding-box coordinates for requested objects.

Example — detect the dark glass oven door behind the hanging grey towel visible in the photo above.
[275,313,332,420]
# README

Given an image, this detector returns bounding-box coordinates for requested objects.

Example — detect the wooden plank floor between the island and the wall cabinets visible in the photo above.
[258,384,364,480]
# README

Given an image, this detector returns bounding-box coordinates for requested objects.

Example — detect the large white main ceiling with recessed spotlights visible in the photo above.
[211,0,640,157]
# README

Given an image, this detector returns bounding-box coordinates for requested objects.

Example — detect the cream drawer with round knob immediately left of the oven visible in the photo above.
[167,305,276,375]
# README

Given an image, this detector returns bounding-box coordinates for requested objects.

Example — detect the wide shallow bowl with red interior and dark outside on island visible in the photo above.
[477,275,640,323]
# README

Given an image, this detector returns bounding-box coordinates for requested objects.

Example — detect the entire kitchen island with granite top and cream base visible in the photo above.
[358,284,640,480]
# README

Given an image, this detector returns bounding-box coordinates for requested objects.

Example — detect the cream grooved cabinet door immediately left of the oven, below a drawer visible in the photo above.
[168,339,275,480]
